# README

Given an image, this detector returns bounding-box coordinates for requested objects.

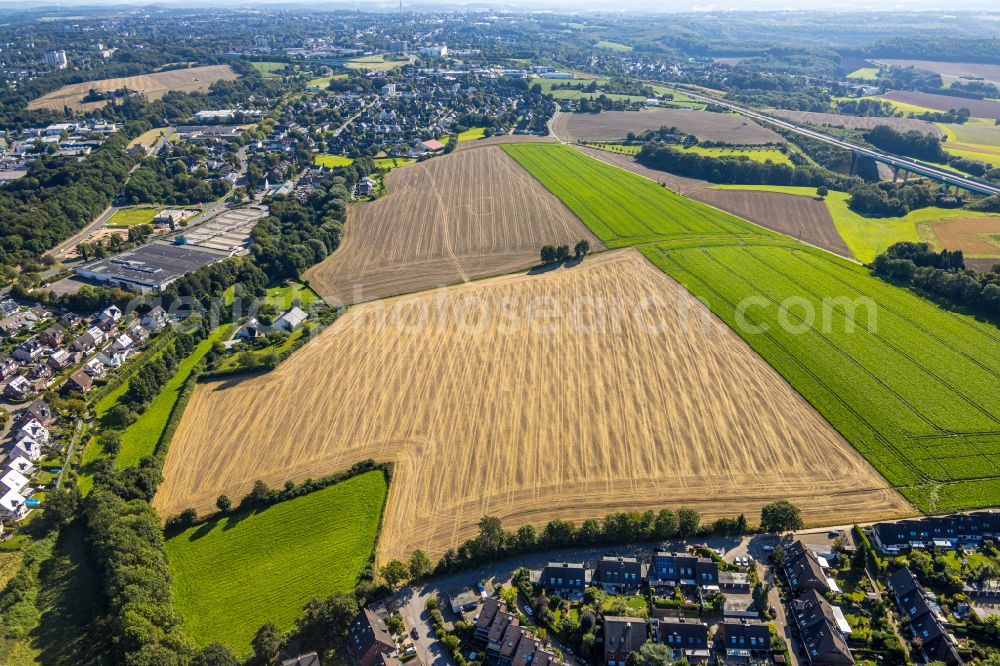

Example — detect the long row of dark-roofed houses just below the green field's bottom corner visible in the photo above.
[871,511,1000,554]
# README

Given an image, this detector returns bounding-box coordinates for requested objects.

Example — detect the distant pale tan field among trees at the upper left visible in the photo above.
[28,65,238,111]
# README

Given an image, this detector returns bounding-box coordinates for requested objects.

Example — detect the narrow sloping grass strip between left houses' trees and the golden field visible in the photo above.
[115,325,229,469]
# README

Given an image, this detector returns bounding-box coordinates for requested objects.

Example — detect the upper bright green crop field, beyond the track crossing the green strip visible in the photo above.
[503,144,774,247]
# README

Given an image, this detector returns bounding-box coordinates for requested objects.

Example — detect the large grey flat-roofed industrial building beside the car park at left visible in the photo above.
[76,241,230,293]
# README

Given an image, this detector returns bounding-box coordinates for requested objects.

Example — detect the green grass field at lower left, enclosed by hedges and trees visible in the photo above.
[167,472,387,654]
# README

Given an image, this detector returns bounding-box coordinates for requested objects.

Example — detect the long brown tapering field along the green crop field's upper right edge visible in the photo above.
[576,146,854,259]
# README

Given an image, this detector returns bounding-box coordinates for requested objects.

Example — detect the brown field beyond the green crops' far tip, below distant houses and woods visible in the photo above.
[552,109,785,145]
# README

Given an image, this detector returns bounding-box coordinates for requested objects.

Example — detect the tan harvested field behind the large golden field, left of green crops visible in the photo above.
[305,146,604,305]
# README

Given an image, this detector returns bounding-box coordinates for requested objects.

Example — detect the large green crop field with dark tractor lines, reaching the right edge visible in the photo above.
[642,242,1000,512]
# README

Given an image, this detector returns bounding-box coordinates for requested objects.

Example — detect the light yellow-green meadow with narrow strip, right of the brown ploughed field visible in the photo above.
[716,185,995,263]
